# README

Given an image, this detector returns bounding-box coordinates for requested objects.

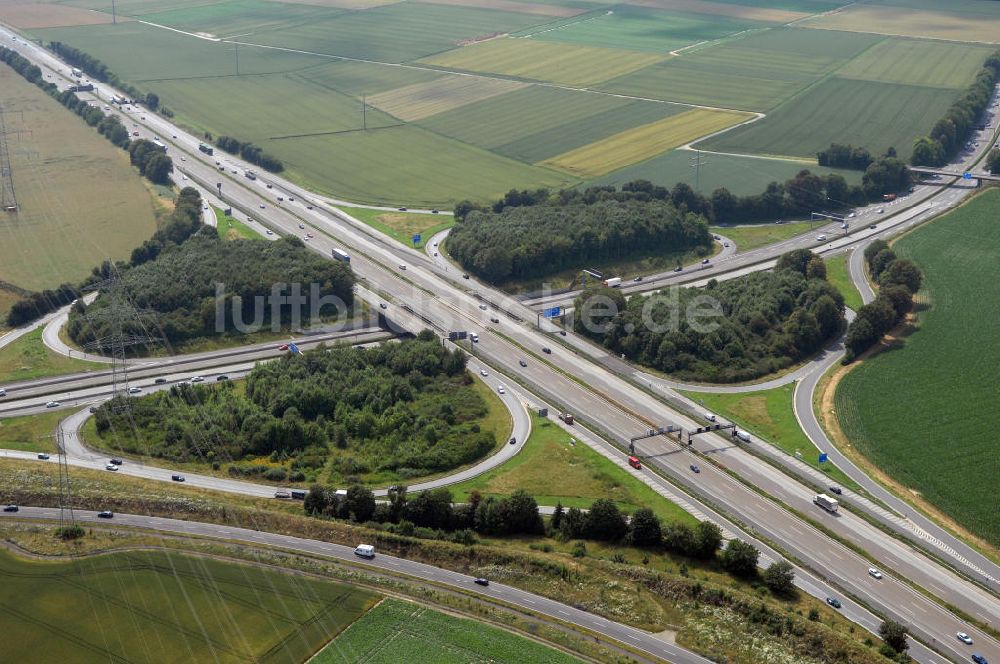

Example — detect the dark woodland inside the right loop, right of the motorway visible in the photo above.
[574,249,845,382]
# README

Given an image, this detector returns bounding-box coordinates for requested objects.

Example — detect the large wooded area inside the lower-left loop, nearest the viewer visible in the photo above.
[96,338,496,483]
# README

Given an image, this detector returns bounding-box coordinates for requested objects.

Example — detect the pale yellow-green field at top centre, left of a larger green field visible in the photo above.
[421,38,664,86]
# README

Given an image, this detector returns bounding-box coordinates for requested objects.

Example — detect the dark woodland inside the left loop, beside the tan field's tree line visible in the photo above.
[67,232,354,344]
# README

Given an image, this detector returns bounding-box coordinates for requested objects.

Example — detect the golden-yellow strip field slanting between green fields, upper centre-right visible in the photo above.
[544,108,753,178]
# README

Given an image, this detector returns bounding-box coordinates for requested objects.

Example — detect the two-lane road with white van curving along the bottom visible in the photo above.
[0,507,709,664]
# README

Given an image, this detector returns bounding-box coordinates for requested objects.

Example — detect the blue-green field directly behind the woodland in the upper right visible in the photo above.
[588,150,861,197]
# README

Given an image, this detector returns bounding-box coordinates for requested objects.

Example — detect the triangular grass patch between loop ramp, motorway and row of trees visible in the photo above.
[448,415,696,525]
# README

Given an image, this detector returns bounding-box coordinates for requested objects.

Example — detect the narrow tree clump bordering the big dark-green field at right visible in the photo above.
[844,240,923,364]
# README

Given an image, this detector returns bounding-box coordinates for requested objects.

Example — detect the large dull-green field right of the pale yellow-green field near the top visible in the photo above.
[599,28,879,111]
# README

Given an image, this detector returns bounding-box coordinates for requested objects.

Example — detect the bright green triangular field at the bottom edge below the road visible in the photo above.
[311,599,580,664]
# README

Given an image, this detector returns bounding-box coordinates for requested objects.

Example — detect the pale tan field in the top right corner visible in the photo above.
[799,0,1000,43]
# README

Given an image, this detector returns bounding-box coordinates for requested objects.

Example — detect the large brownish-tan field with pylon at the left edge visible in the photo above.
[0,64,156,290]
